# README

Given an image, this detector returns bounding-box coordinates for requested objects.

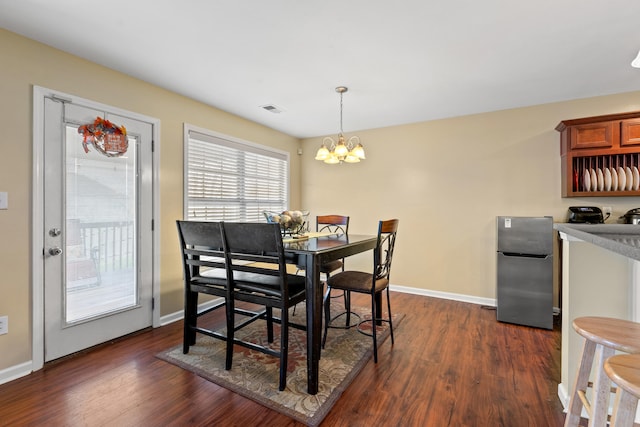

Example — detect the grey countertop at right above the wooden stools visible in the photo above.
[553,223,640,261]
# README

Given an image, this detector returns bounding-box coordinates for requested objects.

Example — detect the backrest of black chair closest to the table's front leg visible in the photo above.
[222,222,288,296]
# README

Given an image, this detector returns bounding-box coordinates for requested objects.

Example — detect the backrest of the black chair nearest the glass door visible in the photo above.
[176,221,225,281]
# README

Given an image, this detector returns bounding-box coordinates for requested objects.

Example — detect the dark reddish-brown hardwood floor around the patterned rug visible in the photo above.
[0,293,564,427]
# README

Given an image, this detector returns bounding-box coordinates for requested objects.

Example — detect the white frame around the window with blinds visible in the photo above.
[182,123,291,221]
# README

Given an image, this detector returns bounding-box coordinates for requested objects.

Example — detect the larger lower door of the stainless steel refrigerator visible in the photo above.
[497,253,553,329]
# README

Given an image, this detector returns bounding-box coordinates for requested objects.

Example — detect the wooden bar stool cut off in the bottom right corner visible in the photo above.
[604,354,640,427]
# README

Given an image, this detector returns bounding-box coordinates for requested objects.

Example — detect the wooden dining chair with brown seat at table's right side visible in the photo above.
[322,219,399,363]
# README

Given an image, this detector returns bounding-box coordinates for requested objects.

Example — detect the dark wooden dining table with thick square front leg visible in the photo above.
[283,233,377,395]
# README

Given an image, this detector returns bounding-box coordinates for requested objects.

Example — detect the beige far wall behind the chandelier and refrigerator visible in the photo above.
[302,92,640,300]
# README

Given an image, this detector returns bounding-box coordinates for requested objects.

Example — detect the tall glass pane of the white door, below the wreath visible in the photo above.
[64,126,138,323]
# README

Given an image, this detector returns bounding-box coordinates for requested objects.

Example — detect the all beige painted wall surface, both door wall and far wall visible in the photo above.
[0,30,640,378]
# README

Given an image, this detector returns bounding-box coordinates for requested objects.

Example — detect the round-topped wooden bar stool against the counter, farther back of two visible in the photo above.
[564,317,640,427]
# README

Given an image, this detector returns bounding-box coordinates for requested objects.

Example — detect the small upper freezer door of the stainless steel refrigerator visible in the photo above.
[497,216,553,255]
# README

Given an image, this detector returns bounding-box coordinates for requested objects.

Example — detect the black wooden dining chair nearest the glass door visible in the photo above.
[176,221,233,369]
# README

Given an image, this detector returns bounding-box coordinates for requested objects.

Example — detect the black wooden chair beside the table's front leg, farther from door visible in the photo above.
[223,222,306,391]
